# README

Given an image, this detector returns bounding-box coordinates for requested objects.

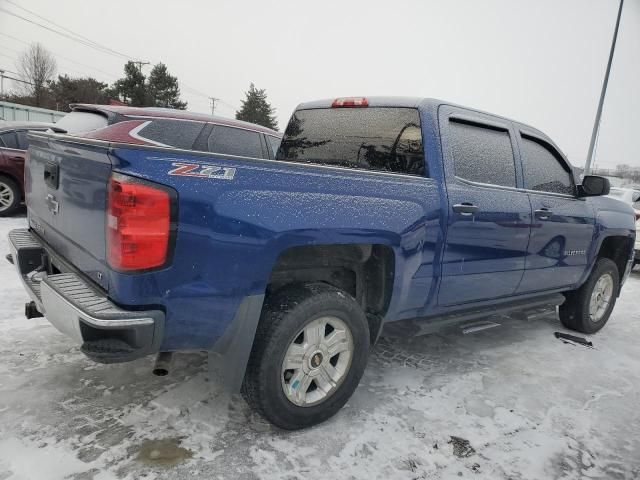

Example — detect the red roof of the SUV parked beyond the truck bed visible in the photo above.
[71,103,282,137]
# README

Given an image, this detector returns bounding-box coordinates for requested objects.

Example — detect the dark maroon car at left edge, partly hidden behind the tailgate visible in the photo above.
[0,121,53,217]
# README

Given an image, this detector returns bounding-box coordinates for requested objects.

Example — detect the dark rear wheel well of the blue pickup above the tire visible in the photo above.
[266,244,394,343]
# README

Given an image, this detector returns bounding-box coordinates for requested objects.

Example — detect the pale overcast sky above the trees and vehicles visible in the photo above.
[0,0,640,166]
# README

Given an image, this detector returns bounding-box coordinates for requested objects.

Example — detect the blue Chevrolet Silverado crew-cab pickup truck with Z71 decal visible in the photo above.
[9,97,635,429]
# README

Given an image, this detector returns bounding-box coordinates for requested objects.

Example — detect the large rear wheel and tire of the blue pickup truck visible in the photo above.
[242,283,370,430]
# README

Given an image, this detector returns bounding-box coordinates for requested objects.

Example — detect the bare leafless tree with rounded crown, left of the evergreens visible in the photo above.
[18,43,57,107]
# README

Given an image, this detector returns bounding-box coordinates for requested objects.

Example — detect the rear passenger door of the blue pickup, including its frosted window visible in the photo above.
[438,107,531,306]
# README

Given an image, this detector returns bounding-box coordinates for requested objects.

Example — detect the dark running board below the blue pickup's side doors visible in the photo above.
[381,293,565,337]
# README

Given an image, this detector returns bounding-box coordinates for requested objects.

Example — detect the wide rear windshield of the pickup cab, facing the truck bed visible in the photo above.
[276,107,426,175]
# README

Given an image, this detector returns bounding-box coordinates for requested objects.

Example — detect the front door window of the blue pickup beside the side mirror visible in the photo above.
[522,135,574,195]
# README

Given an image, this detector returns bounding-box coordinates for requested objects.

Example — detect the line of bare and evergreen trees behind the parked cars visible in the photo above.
[0,43,278,129]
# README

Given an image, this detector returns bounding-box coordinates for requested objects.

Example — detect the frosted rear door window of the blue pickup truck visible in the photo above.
[449,119,516,187]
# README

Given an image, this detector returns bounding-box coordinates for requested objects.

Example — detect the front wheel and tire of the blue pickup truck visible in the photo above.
[559,258,620,333]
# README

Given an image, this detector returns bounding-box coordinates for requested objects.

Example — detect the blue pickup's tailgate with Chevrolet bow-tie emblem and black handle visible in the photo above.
[25,134,111,289]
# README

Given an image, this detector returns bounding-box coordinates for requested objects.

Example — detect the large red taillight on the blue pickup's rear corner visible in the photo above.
[107,173,172,271]
